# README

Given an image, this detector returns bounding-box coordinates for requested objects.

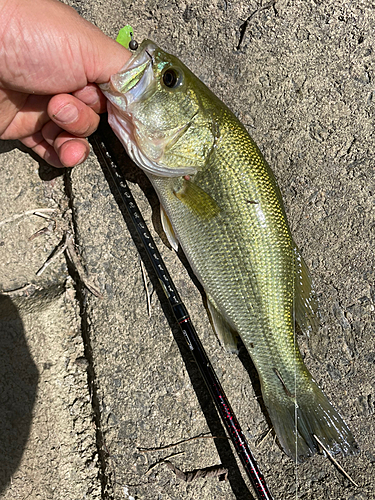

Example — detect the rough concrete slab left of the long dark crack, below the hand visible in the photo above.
[0,142,101,500]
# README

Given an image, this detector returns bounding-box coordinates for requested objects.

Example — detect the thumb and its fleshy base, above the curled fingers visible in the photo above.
[0,0,131,95]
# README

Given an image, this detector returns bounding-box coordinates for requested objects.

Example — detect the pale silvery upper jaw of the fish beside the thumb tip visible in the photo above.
[111,40,157,107]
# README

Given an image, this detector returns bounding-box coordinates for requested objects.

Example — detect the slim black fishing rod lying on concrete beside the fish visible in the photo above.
[92,133,273,500]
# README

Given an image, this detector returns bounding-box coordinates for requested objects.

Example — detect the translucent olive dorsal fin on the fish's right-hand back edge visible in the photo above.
[295,248,319,333]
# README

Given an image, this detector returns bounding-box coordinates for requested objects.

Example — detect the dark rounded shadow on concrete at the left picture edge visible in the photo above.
[0,295,38,496]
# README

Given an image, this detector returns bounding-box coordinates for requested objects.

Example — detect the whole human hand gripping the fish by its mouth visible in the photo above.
[0,0,130,167]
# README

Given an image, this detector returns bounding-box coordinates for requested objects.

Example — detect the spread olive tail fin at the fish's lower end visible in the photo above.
[263,380,359,463]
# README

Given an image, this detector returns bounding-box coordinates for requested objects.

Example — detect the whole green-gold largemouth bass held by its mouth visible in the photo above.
[100,40,358,463]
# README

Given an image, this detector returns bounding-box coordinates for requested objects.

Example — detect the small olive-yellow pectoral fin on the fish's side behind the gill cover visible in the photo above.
[174,179,220,219]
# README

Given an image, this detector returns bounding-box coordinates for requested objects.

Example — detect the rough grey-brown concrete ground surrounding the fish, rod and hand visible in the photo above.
[0,0,375,500]
